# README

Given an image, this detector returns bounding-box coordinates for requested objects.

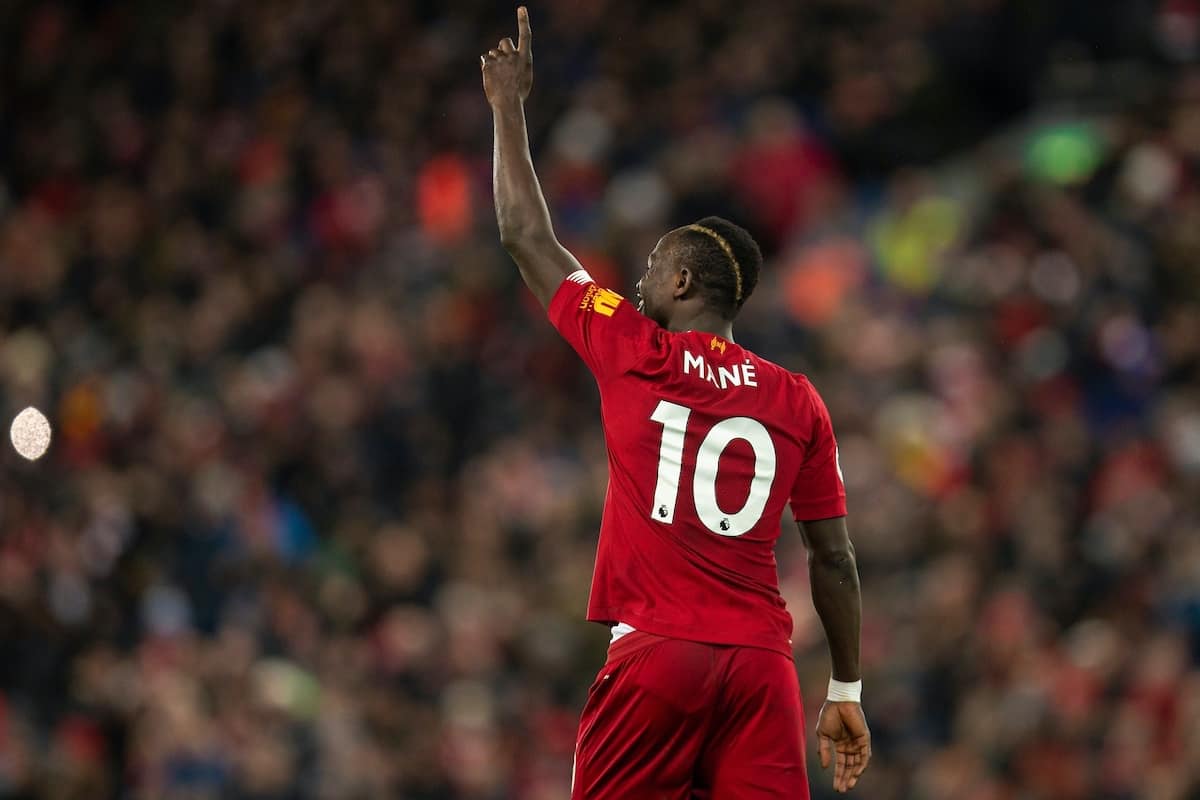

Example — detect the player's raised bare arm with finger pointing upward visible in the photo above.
[480,6,580,307]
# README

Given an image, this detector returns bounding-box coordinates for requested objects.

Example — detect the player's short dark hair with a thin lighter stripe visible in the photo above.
[680,217,762,319]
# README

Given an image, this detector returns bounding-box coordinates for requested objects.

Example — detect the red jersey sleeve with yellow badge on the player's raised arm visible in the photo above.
[548,270,664,379]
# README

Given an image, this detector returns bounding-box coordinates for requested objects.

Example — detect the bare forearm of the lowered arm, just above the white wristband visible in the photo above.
[809,542,863,681]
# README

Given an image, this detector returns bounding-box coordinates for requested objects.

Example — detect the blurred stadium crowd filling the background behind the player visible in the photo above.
[0,0,1200,800]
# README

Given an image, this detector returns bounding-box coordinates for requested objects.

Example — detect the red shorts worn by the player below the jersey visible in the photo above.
[571,631,809,800]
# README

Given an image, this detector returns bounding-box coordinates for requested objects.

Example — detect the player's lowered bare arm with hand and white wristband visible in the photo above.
[798,517,871,792]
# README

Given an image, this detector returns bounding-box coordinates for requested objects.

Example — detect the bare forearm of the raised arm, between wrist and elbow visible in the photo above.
[492,102,554,248]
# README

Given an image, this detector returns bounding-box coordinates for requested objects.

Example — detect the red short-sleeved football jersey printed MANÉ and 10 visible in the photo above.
[550,270,846,655]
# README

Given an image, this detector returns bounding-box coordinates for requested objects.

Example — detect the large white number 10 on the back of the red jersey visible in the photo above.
[650,401,775,536]
